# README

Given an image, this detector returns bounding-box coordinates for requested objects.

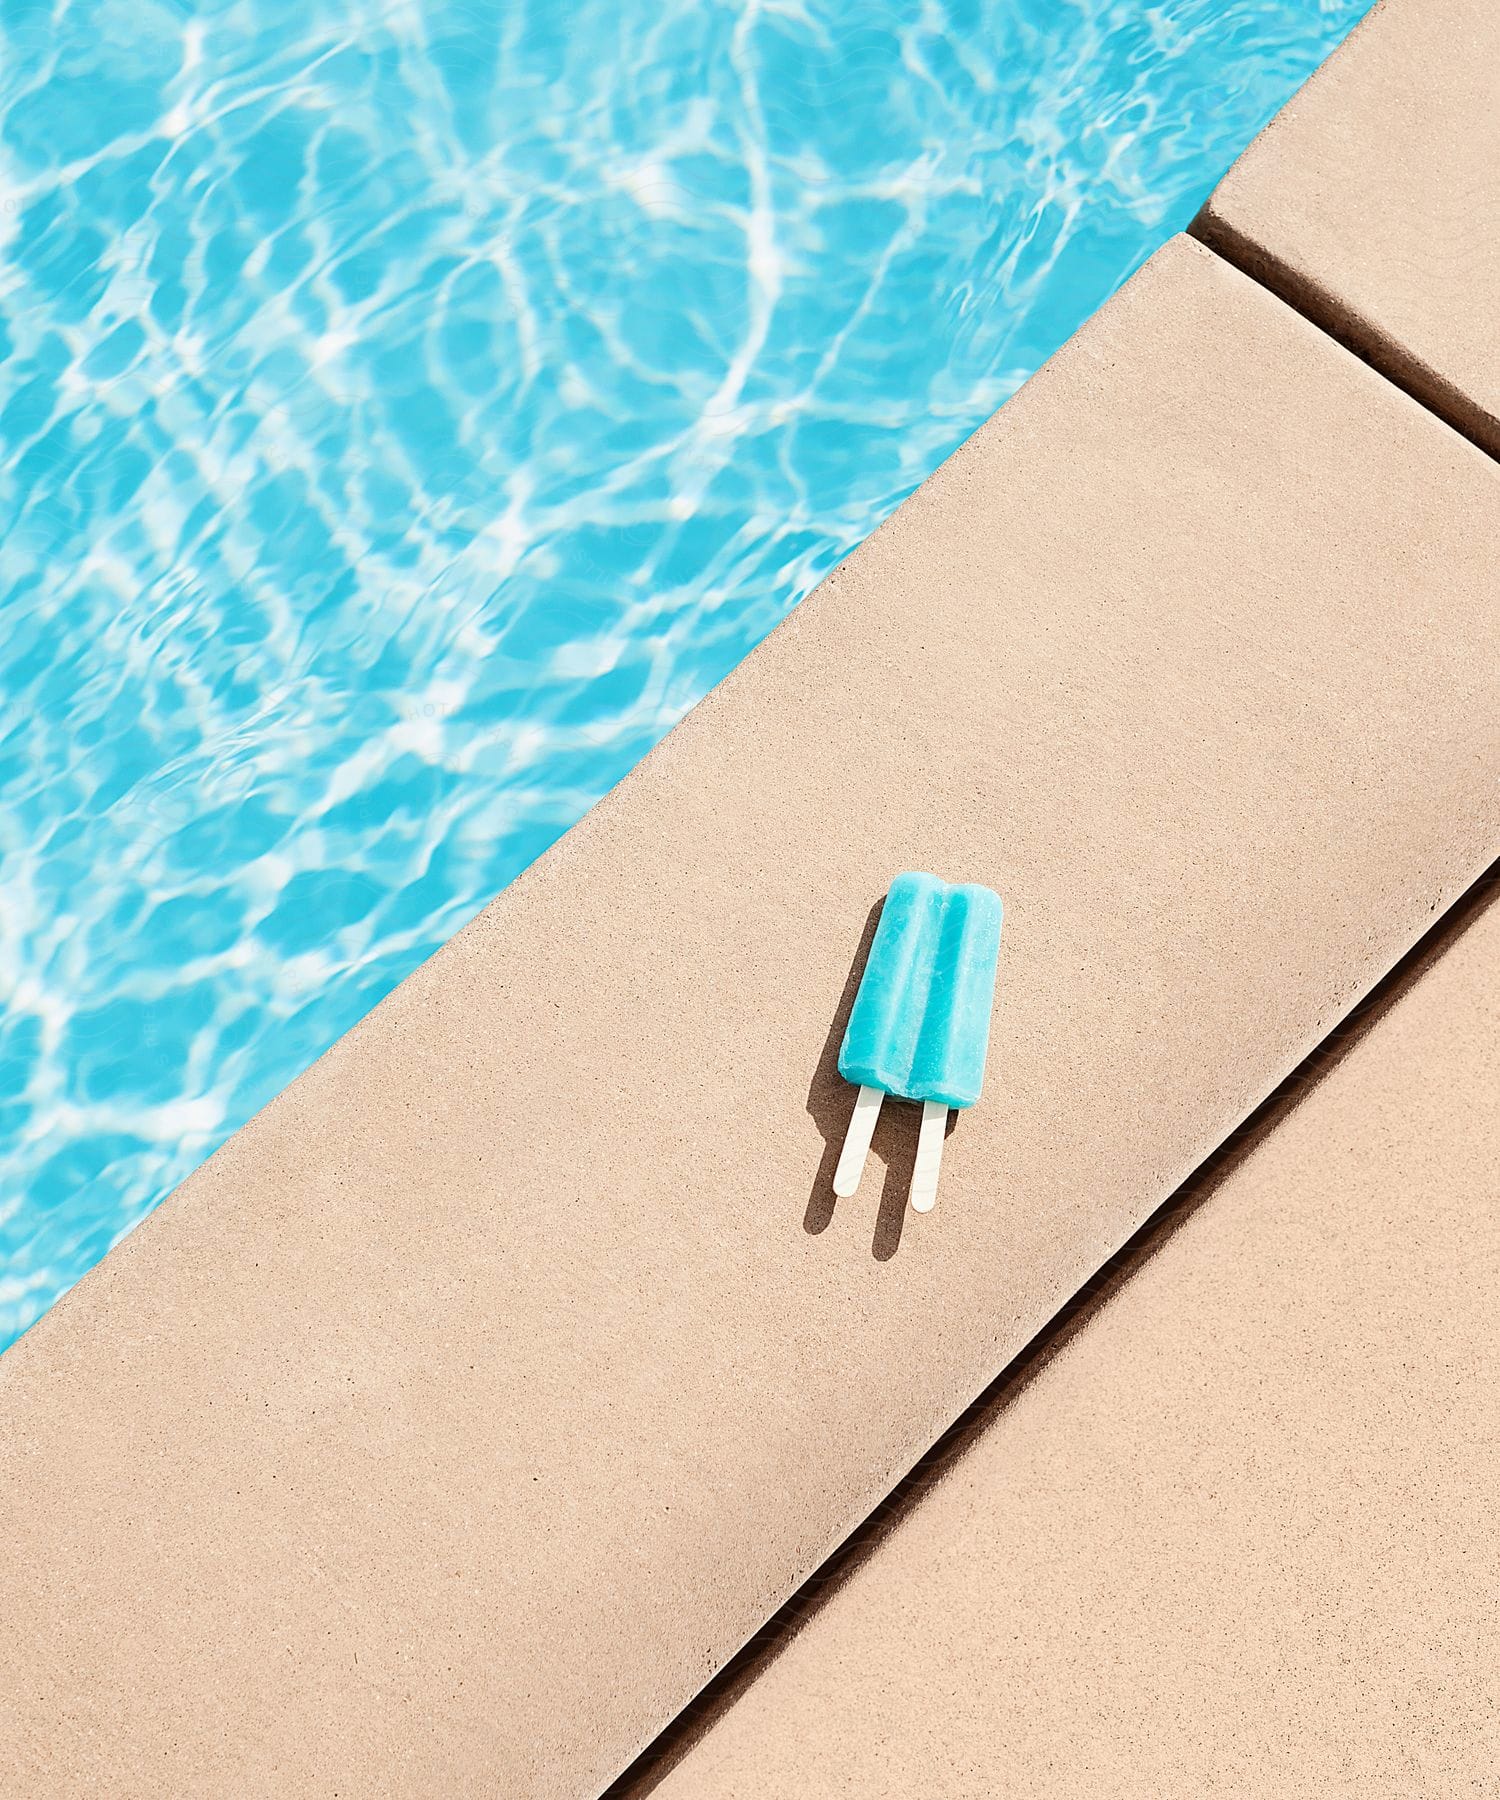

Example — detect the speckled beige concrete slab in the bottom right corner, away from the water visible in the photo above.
[637,882,1500,1800]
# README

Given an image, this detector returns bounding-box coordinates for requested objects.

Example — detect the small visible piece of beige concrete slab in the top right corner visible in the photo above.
[1194,0,1500,455]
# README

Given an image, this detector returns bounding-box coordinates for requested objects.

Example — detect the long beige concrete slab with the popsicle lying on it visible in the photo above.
[0,239,1500,1800]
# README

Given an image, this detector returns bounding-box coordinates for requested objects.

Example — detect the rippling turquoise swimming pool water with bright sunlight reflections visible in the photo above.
[0,0,1367,1345]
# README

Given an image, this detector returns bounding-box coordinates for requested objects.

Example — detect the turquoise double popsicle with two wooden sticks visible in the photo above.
[834,873,1001,1213]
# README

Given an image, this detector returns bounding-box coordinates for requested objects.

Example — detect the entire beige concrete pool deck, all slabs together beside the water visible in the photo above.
[0,0,1500,1800]
